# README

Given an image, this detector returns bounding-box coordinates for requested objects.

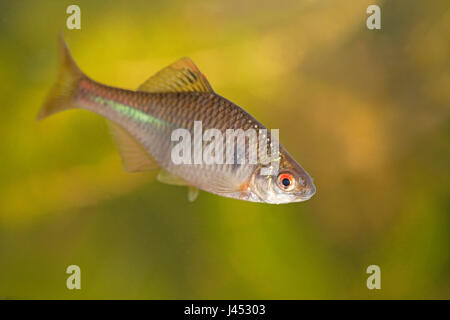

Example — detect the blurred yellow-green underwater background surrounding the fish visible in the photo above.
[0,0,450,299]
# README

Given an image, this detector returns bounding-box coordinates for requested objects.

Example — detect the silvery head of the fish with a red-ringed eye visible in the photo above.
[250,152,316,204]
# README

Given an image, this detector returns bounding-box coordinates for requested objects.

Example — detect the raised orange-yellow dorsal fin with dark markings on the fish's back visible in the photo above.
[137,58,214,92]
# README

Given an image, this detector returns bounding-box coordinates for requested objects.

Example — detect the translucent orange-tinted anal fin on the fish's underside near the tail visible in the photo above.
[108,121,159,172]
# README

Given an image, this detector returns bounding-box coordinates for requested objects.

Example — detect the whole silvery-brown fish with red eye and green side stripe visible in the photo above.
[37,36,316,204]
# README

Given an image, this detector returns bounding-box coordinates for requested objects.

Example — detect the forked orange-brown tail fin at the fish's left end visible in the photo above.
[37,35,84,120]
